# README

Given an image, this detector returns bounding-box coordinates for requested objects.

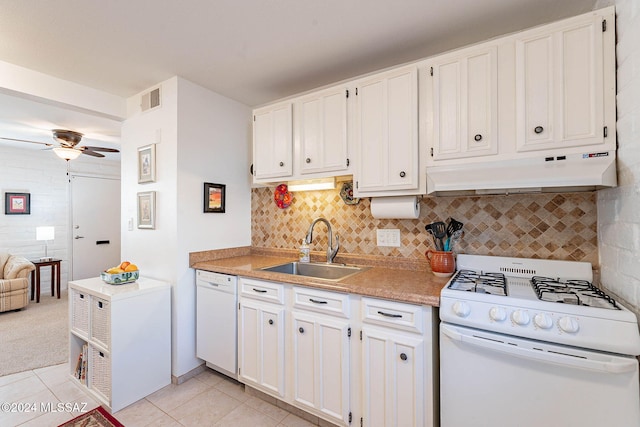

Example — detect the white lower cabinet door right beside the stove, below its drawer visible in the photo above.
[362,327,425,427]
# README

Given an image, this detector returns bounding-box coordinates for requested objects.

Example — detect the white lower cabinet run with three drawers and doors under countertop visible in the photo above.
[238,278,437,427]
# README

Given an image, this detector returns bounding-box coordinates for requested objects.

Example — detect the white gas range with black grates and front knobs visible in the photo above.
[440,254,640,427]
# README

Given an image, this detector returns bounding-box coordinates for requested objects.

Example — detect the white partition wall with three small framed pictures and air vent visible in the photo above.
[122,77,251,376]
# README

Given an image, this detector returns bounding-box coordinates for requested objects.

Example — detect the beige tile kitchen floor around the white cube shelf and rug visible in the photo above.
[0,364,336,427]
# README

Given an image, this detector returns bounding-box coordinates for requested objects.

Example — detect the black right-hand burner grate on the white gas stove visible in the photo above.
[531,276,620,310]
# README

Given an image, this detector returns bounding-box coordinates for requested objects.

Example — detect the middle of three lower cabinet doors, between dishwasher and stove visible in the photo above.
[292,312,350,425]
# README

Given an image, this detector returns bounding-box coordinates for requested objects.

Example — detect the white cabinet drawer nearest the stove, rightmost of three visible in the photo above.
[362,297,424,333]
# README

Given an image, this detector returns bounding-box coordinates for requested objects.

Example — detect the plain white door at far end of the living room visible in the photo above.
[71,175,120,280]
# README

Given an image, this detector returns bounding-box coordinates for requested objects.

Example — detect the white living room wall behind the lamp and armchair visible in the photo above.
[0,146,120,294]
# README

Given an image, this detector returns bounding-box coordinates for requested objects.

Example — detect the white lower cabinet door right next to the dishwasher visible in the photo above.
[238,300,284,396]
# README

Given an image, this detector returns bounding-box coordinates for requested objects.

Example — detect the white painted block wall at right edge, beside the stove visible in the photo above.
[598,0,640,312]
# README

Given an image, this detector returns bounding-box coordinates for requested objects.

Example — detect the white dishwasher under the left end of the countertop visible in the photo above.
[196,270,238,379]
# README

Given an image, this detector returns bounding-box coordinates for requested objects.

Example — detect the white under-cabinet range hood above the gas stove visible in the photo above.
[427,151,617,195]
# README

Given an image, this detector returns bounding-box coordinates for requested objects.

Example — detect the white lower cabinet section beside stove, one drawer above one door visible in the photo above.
[361,297,435,427]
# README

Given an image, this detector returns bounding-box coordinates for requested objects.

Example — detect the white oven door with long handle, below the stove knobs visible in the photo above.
[440,323,640,427]
